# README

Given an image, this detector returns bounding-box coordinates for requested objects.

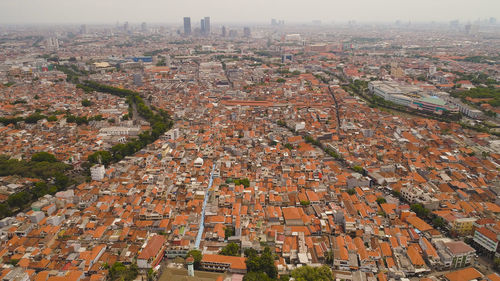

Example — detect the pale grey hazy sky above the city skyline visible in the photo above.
[0,0,500,24]
